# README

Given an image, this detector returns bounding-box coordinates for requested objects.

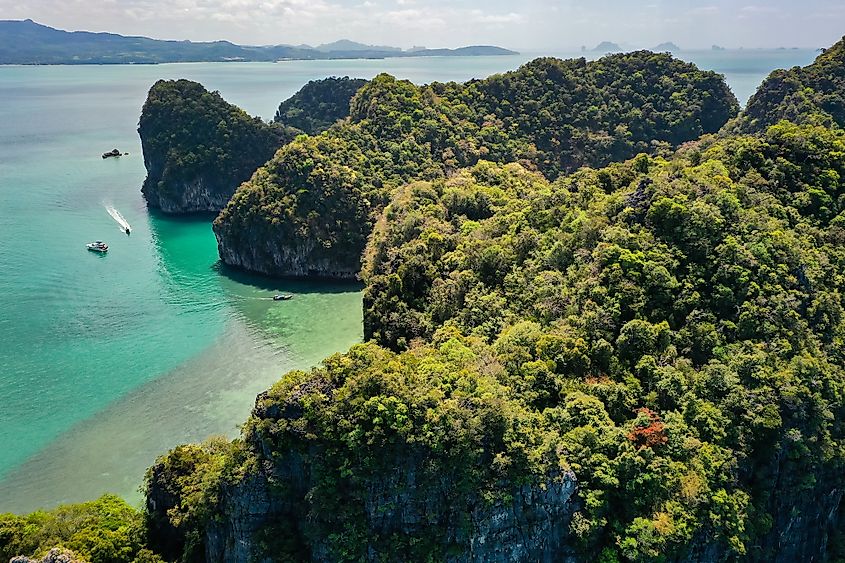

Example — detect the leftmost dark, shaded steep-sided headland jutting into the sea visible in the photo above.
[138,80,297,213]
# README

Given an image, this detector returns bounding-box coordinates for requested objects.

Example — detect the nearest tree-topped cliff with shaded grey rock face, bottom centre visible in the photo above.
[147,340,579,563]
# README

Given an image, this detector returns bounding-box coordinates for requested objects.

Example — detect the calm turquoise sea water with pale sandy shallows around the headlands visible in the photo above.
[0,51,815,512]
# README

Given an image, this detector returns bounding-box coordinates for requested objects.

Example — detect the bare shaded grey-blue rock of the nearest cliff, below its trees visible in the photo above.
[201,452,577,563]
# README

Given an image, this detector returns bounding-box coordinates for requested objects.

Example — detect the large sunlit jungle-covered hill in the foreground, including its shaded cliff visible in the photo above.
[150,123,845,561]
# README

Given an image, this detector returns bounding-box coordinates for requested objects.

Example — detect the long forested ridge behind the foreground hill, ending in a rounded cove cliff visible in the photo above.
[215,51,738,278]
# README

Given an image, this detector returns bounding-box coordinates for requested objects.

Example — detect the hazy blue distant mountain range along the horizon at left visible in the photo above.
[0,20,518,64]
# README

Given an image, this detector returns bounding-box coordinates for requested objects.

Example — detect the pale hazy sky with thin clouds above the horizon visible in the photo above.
[0,0,845,51]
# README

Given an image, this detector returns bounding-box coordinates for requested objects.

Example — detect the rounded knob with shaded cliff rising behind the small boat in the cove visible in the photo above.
[214,135,375,280]
